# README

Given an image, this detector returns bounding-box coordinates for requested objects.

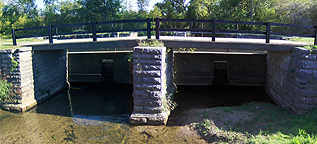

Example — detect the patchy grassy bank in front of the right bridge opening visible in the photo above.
[195,103,317,144]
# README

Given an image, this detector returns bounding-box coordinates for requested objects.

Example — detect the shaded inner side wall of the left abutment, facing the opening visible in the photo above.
[33,50,67,101]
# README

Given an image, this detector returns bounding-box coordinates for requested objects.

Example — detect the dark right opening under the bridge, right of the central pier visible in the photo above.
[171,51,274,122]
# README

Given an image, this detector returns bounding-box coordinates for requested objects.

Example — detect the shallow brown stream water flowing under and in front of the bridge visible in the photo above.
[0,84,270,144]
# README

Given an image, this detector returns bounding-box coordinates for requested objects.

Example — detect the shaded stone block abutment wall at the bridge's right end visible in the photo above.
[266,48,317,114]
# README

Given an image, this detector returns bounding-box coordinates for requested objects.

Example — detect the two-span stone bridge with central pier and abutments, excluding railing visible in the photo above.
[1,36,317,125]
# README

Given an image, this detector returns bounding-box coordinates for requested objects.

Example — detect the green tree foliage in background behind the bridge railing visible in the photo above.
[0,0,317,38]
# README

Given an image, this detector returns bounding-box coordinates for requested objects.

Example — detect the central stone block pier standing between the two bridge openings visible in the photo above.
[130,47,175,125]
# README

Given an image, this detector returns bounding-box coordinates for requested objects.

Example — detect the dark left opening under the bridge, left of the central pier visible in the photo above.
[67,50,133,117]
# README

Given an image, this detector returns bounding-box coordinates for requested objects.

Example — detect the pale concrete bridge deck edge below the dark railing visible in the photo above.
[24,36,308,51]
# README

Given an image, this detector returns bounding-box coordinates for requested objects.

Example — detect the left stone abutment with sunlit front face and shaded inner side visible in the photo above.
[0,48,67,112]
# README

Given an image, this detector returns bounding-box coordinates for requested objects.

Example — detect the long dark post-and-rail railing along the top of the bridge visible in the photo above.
[12,18,317,45]
